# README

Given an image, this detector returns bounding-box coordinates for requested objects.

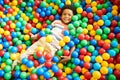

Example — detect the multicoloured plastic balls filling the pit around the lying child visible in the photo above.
[0,0,120,80]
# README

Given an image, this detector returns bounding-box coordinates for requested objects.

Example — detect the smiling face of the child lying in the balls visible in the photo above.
[61,9,73,24]
